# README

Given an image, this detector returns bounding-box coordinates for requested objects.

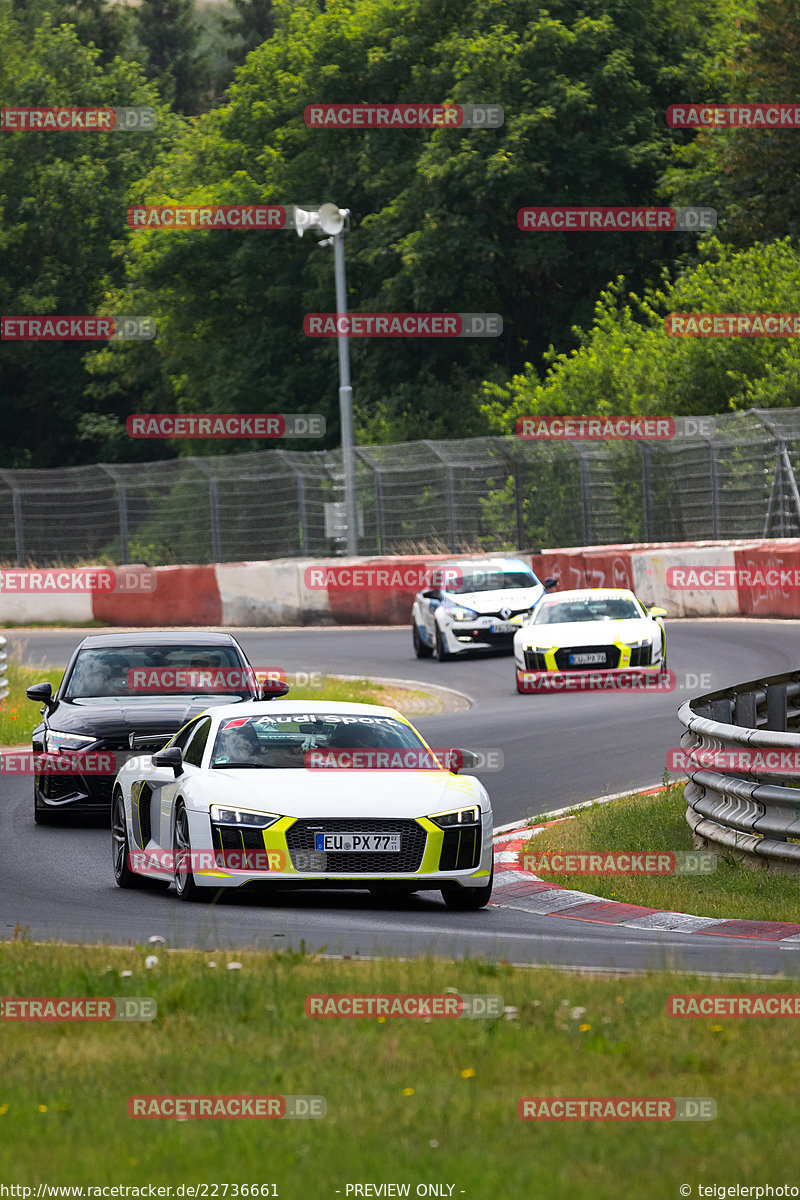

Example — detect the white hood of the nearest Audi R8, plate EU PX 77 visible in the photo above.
[186,767,487,818]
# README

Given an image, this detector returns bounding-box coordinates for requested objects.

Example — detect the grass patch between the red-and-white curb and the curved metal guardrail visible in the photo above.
[523,784,800,922]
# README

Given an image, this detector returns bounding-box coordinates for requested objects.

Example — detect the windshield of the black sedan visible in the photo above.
[64,642,253,700]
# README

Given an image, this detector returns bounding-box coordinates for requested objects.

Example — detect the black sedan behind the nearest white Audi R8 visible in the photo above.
[28,631,288,824]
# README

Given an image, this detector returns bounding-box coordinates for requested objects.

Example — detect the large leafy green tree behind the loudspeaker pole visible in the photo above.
[103,0,724,452]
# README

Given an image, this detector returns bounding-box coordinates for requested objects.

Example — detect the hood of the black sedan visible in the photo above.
[47,696,237,738]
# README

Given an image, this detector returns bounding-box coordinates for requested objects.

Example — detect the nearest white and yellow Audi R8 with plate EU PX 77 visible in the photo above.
[112,700,493,911]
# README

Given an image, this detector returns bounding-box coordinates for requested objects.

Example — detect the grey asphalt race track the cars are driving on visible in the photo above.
[0,619,800,974]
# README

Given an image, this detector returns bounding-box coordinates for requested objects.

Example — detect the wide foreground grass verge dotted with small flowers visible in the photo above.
[0,941,800,1200]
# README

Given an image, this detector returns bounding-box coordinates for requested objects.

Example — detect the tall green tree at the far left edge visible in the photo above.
[0,2,174,467]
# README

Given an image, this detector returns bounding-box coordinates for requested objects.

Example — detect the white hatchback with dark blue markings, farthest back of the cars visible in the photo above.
[411,558,558,662]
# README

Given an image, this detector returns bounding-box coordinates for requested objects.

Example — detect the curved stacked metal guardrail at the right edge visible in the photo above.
[678,671,800,870]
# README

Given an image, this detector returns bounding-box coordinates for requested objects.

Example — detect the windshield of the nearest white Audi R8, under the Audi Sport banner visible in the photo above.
[211,712,426,768]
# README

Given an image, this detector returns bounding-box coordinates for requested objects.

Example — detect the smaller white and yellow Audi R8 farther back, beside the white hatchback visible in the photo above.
[513,588,667,691]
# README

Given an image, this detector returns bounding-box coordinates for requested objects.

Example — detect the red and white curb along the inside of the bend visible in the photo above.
[491,820,800,948]
